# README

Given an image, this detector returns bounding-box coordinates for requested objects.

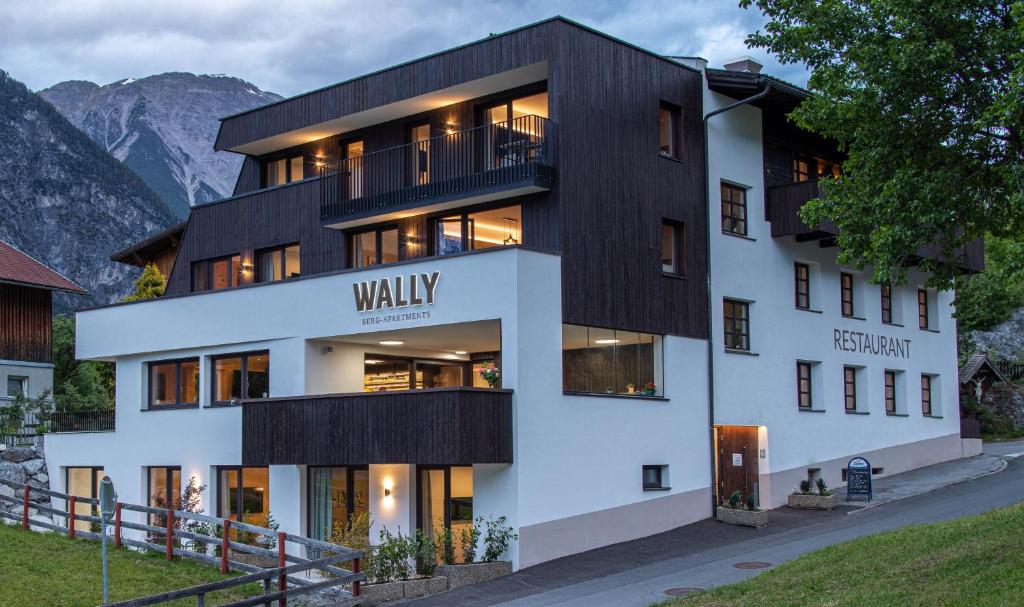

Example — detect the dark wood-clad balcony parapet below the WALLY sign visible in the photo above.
[242,388,512,466]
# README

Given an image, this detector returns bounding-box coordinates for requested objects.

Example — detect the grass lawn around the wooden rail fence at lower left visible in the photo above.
[0,523,260,607]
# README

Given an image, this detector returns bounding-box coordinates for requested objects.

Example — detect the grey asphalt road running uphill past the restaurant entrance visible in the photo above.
[406,441,1024,607]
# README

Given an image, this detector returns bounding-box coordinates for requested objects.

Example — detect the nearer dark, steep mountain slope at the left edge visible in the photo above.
[0,71,177,311]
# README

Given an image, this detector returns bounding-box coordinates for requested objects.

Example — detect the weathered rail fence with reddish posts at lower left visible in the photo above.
[0,479,366,607]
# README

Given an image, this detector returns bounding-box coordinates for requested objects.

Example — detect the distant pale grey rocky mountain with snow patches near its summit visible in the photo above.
[39,73,282,217]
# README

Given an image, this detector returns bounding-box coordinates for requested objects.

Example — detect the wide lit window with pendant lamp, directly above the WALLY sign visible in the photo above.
[433,205,522,255]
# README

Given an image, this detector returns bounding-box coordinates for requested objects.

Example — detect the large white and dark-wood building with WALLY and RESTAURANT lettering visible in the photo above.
[47,17,977,567]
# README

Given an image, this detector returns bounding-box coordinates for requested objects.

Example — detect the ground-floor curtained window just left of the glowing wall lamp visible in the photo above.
[309,466,370,541]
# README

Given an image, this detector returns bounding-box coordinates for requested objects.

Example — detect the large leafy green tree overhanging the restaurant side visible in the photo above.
[740,0,1024,287]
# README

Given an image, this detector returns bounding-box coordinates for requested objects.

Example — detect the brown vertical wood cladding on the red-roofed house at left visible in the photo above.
[0,284,53,362]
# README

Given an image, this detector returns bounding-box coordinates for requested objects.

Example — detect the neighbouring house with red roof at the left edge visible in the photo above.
[0,241,85,399]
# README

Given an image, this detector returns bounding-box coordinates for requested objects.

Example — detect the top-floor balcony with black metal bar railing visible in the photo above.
[319,116,554,228]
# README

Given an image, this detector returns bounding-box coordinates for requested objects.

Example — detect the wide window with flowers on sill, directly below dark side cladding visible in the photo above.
[562,324,662,396]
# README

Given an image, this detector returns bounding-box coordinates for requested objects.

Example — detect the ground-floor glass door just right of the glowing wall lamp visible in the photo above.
[416,466,473,562]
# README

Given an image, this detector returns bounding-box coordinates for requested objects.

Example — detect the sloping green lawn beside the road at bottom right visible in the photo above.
[663,504,1024,607]
